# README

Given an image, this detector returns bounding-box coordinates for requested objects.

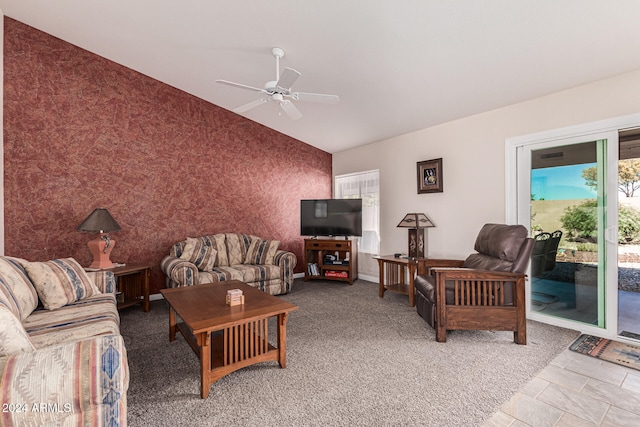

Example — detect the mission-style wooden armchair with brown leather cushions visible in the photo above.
[414,224,534,344]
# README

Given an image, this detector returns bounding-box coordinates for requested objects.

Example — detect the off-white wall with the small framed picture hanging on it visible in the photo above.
[333,70,640,258]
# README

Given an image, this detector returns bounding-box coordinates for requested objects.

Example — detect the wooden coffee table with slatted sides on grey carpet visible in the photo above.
[160,280,298,399]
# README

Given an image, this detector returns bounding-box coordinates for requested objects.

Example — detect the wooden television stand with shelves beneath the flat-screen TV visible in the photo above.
[304,237,358,285]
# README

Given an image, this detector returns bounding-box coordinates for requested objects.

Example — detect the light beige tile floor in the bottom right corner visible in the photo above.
[484,349,640,427]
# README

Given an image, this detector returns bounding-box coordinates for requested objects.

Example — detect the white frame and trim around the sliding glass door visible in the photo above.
[505,114,640,339]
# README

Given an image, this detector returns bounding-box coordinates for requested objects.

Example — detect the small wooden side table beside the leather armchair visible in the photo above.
[373,255,422,307]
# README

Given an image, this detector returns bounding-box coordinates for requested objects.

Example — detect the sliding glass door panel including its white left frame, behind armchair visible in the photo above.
[517,133,617,330]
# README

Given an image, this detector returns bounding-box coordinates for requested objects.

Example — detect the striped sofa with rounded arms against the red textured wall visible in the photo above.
[160,233,297,295]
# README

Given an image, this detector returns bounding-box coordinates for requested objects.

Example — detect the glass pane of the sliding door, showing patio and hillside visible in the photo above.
[529,140,607,327]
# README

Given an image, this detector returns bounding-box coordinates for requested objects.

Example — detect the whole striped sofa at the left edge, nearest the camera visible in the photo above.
[0,257,129,426]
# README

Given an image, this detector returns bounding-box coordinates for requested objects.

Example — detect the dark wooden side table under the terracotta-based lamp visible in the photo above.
[110,264,153,312]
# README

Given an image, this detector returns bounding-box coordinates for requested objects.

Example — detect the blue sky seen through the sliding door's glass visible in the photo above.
[531,163,596,200]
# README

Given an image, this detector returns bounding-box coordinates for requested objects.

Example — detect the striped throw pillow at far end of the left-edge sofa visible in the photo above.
[24,258,100,310]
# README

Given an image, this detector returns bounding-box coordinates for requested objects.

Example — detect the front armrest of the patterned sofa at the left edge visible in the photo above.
[0,335,129,426]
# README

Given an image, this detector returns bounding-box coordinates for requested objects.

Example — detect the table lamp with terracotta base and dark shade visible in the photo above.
[77,208,120,269]
